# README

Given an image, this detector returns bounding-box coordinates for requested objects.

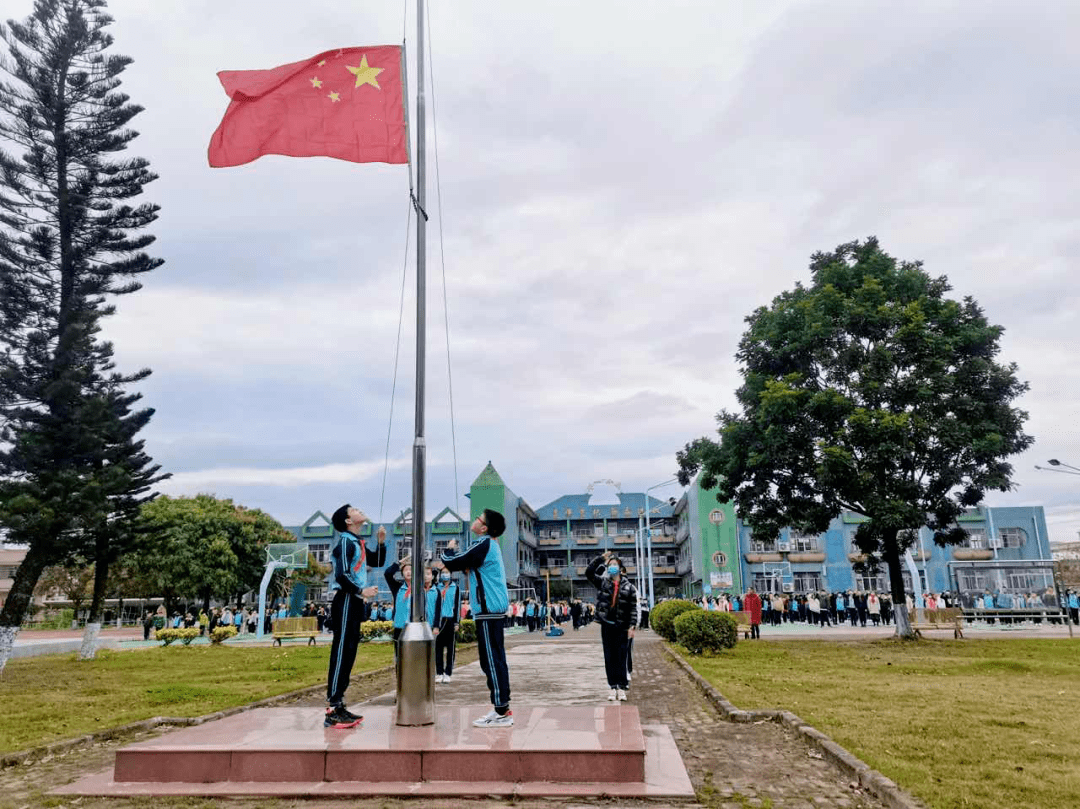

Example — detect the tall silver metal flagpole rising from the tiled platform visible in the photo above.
[396,0,435,725]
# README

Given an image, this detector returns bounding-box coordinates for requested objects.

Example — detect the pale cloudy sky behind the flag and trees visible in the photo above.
[21,0,1080,540]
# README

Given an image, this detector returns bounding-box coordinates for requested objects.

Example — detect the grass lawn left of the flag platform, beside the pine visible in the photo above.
[0,644,393,752]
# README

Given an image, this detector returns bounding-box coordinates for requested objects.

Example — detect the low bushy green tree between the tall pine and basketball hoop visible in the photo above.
[133,495,296,615]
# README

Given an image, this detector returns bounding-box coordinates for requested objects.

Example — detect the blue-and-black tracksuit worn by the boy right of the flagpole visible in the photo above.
[443,536,510,715]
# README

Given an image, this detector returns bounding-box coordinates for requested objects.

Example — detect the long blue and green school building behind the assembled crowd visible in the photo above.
[289,462,1053,601]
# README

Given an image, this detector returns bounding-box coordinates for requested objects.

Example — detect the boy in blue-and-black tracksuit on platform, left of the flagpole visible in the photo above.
[323,503,387,728]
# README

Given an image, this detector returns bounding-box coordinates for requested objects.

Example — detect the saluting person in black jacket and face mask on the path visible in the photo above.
[585,551,640,702]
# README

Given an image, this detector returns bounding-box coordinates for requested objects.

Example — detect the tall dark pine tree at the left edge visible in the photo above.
[0,0,162,672]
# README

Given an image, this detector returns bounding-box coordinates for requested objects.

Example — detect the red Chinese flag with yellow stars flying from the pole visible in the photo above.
[210,45,408,166]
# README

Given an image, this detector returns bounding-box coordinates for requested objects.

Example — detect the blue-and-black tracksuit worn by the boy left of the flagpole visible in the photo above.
[326,531,387,705]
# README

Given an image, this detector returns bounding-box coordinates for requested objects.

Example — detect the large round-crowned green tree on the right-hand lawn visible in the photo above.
[677,239,1032,635]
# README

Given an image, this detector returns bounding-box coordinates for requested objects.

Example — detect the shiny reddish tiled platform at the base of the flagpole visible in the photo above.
[56,704,693,797]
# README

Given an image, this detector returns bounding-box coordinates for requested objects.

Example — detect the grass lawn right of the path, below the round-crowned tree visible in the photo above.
[686,638,1080,809]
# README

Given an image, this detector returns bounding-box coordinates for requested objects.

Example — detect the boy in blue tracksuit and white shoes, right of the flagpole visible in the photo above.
[443,509,514,728]
